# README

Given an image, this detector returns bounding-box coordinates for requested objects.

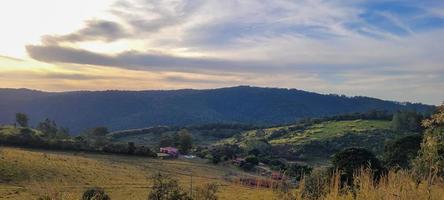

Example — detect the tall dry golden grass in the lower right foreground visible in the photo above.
[282,169,444,200]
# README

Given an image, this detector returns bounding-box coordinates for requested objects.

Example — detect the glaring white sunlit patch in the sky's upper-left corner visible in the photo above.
[0,0,112,58]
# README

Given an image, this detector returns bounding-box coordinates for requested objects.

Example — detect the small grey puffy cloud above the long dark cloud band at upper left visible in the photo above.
[42,20,128,44]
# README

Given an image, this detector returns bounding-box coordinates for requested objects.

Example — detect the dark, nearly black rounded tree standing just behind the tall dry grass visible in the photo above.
[332,147,383,185]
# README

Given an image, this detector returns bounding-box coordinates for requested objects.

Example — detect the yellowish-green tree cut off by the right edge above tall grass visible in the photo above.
[414,104,444,179]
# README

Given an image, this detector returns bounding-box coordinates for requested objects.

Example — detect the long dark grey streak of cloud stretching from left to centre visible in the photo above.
[26,45,274,72]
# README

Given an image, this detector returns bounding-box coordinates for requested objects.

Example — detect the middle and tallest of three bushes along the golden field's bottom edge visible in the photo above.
[148,173,191,200]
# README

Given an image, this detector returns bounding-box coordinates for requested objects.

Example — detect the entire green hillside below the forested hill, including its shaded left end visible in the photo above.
[109,119,413,165]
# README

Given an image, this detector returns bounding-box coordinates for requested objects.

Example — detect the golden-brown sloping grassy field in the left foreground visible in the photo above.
[0,147,274,200]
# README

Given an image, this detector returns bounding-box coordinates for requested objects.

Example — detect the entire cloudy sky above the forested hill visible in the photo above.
[0,0,444,104]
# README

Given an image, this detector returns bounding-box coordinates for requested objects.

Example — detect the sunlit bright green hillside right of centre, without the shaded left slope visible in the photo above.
[219,120,413,164]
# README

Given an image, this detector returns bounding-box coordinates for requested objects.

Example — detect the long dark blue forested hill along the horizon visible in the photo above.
[0,86,432,133]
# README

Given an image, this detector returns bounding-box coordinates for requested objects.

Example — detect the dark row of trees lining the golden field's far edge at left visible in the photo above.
[0,113,156,157]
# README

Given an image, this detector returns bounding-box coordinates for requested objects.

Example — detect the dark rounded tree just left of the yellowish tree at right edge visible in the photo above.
[383,134,422,169]
